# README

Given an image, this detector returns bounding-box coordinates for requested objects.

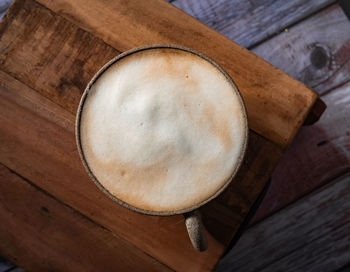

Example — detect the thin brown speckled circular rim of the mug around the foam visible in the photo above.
[75,44,249,216]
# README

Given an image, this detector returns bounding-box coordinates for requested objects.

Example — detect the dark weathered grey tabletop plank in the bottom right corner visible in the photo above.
[217,174,350,272]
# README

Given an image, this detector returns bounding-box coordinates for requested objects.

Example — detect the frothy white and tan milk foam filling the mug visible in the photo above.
[80,48,246,212]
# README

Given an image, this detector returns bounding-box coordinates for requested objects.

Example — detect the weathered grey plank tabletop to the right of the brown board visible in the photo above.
[172,0,350,272]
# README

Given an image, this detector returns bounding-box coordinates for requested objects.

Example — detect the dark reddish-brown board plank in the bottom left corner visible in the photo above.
[0,164,172,271]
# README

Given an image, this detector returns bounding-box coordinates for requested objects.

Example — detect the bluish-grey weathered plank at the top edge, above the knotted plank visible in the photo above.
[172,0,335,47]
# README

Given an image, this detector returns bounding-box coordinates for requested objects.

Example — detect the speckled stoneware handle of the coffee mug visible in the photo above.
[184,210,208,251]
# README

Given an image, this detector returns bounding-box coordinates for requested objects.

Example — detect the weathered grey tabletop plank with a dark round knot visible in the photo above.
[252,2,350,94]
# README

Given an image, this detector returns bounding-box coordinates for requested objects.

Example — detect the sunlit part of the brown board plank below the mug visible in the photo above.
[0,72,224,271]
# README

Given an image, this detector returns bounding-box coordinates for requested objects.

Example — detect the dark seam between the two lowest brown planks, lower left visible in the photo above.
[0,162,175,271]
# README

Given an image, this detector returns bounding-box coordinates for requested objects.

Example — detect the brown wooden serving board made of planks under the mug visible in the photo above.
[0,0,324,271]
